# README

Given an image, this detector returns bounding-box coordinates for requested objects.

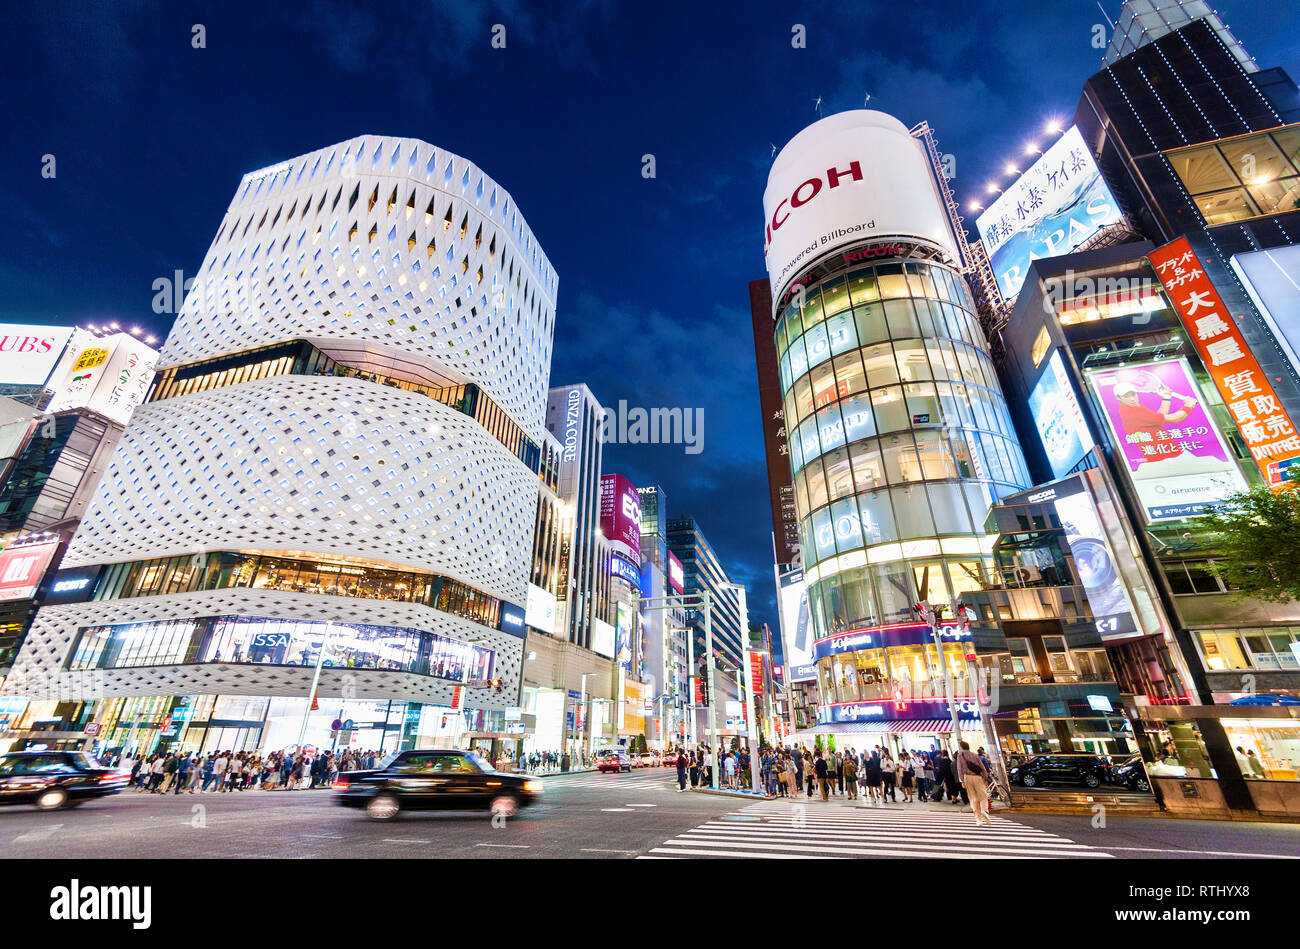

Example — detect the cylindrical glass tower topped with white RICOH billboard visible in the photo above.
[764,111,1030,733]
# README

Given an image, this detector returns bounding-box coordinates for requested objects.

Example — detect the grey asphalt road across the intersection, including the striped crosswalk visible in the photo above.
[0,768,1300,859]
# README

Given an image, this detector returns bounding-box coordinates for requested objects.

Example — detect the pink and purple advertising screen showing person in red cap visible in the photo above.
[1086,359,1245,521]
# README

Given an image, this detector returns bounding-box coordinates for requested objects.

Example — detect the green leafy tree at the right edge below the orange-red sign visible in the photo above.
[1201,488,1300,603]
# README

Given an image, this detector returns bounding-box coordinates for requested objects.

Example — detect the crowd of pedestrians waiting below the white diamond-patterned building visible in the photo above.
[112,750,384,794]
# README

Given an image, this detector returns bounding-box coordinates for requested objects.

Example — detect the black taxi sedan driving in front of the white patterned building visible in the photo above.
[334,750,542,820]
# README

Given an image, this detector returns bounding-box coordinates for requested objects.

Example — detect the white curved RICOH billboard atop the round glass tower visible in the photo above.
[763,109,957,299]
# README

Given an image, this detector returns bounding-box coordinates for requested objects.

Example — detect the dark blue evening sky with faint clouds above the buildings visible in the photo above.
[0,0,1300,623]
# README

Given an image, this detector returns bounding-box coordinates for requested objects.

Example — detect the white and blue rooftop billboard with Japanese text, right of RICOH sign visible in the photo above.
[975,126,1123,300]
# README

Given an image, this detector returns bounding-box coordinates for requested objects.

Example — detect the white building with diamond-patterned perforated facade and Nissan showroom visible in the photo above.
[5,137,556,751]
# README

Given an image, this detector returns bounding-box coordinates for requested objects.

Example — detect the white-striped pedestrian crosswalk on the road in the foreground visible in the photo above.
[642,801,1110,859]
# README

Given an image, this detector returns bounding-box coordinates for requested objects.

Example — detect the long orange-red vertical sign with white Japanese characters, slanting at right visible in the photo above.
[1148,238,1300,484]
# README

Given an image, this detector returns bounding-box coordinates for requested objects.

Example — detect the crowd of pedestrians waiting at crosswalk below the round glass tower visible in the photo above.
[677,741,993,824]
